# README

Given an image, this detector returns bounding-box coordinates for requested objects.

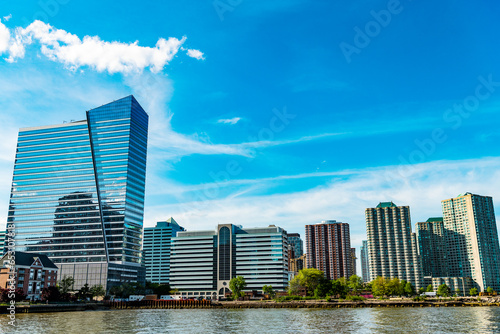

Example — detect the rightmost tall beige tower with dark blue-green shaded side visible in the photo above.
[441,193,500,291]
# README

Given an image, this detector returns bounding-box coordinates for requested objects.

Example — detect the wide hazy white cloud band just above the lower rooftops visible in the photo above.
[145,158,500,247]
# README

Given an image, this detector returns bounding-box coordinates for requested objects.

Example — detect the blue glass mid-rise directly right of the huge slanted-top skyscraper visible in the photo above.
[142,218,185,284]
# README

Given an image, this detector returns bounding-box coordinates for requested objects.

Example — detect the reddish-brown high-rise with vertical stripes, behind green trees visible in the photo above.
[306,220,354,280]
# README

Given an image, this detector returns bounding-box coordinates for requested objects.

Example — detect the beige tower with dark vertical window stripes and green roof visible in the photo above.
[365,202,423,289]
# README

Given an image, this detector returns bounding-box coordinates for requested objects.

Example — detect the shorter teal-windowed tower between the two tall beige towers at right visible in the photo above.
[416,217,448,277]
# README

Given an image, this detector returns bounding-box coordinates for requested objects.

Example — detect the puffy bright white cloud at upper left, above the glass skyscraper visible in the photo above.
[0,20,204,74]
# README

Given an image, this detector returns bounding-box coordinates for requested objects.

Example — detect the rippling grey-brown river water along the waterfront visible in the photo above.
[0,307,500,334]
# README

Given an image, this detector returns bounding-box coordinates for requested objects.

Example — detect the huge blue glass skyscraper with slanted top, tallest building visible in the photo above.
[8,96,148,289]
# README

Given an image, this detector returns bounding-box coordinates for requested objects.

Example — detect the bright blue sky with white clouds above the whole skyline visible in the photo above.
[0,0,500,260]
